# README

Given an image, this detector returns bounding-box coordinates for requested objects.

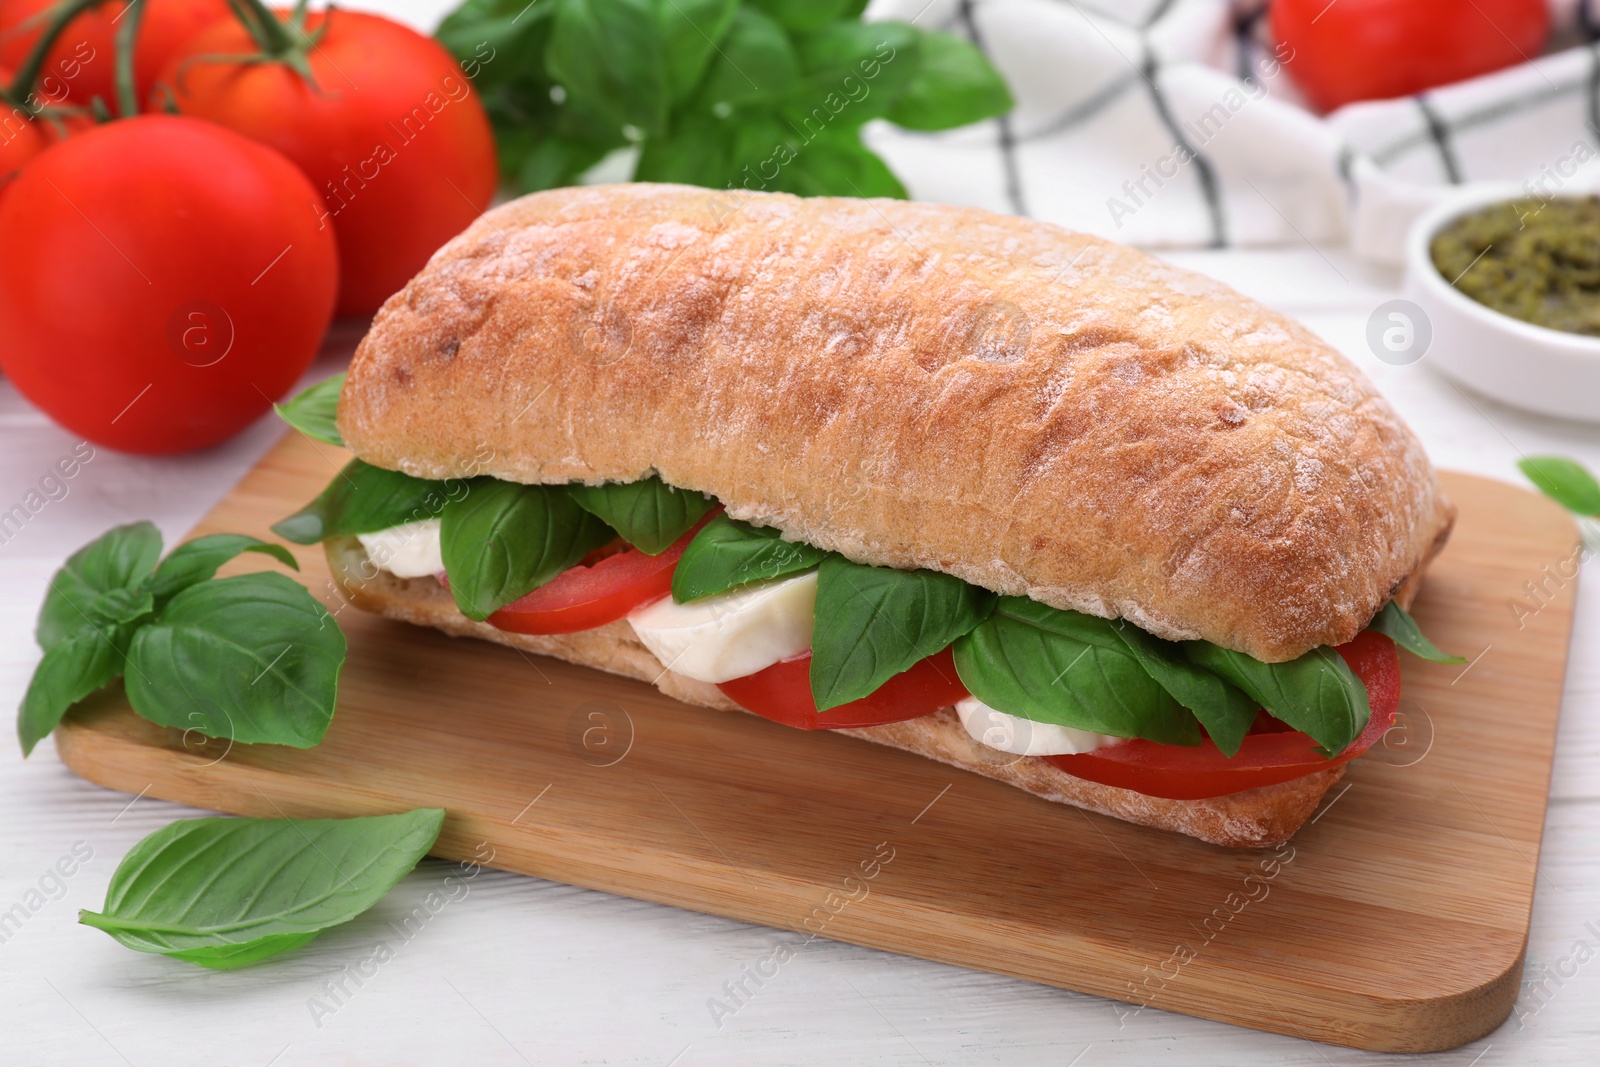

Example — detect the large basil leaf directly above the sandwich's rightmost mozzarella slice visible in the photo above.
[954,597,1200,745]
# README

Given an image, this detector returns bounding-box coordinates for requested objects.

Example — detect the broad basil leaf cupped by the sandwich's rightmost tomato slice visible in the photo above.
[1184,641,1371,758]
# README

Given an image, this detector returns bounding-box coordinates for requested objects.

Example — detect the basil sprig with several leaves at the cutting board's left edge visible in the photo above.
[18,522,346,755]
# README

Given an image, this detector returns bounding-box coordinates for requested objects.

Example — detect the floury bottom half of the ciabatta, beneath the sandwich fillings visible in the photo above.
[325,537,1344,848]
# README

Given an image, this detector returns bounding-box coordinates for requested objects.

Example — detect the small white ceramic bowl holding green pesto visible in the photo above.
[1405,186,1600,422]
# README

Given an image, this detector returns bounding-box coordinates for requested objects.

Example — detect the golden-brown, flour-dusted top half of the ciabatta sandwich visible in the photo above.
[339,186,1451,662]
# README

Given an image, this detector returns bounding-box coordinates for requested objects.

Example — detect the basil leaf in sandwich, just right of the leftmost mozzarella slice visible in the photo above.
[440,478,616,621]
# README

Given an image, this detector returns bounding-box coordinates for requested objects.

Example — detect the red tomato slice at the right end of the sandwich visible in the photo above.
[1045,630,1400,800]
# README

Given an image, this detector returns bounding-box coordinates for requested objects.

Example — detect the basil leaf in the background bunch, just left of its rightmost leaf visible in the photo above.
[784,22,922,125]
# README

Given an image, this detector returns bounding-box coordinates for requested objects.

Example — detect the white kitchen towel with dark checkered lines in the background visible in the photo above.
[867,0,1600,262]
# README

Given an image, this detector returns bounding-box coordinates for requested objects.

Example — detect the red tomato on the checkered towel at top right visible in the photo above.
[1270,0,1550,110]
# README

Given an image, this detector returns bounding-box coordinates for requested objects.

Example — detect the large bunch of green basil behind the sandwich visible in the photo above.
[438,0,1011,197]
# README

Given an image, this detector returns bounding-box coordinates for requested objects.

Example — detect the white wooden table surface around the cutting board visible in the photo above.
[0,0,1600,1067]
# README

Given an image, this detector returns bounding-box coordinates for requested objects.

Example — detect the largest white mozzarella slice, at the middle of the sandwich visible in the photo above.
[627,571,816,683]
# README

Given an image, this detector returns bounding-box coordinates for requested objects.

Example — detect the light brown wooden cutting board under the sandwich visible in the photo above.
[56,435,1578,1051]
